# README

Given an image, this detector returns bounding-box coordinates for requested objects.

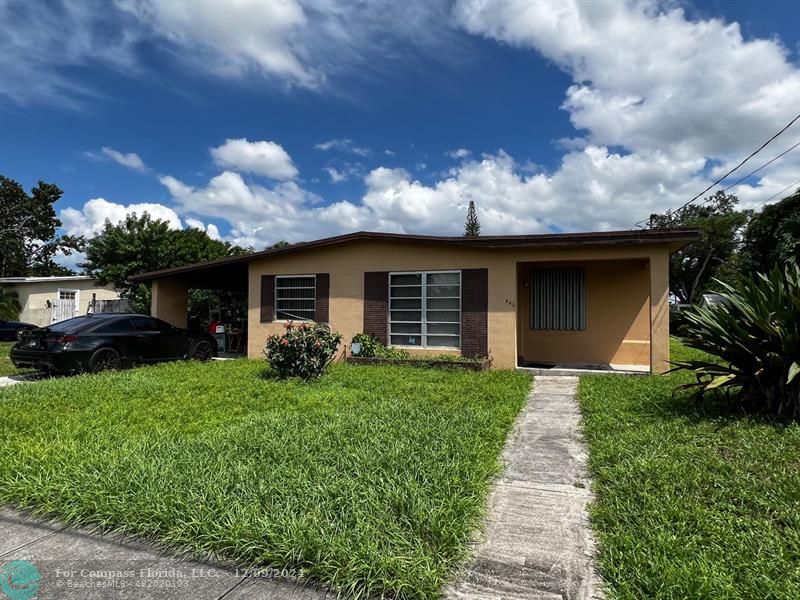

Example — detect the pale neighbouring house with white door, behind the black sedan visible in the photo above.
[0,275,119,327]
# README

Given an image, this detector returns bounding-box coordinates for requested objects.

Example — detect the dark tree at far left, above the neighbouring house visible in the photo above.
[0,175,84,277]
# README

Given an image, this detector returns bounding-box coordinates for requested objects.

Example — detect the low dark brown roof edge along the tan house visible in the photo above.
[133,229,700,281]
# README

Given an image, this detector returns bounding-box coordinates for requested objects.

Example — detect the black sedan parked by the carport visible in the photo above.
[10,314,217,373]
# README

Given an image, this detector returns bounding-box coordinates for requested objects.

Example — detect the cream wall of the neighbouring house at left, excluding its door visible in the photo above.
[3,279,119,326]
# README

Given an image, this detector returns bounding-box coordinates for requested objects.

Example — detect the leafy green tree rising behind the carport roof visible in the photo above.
[80,213,249,312]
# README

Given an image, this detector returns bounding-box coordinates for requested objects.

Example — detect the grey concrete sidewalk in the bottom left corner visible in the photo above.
[0,509,335,600]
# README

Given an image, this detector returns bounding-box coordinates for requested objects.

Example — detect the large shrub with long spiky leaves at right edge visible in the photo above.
[673,263,800,418]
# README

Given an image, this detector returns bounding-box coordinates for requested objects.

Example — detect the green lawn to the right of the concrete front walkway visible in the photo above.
[579,343,800,599]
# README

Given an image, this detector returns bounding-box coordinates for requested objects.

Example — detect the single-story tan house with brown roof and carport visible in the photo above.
[135,230,698,372]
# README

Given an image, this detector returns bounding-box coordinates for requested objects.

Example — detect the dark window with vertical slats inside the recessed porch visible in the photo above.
[531,267,586,331]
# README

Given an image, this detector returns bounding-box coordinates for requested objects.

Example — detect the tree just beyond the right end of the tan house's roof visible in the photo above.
[650,191,750,304]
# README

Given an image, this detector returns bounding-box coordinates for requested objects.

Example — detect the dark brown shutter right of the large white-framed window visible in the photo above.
[461,269,489,356]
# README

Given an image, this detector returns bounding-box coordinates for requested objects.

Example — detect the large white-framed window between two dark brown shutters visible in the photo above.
[389,271,461,348]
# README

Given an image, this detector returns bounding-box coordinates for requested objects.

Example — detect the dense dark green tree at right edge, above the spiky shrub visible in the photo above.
[741,189,800,273]
